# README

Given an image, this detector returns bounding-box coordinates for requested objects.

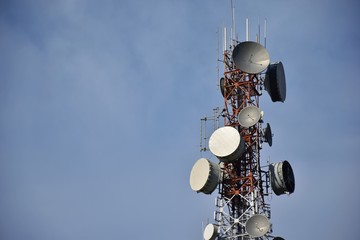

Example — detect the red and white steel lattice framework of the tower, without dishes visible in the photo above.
[214,49,272,239]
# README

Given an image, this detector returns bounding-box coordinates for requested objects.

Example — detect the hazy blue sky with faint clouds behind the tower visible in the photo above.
[0,0,360,240]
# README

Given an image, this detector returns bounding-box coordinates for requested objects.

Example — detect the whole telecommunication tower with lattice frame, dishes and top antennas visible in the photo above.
[190,4,295,240]
